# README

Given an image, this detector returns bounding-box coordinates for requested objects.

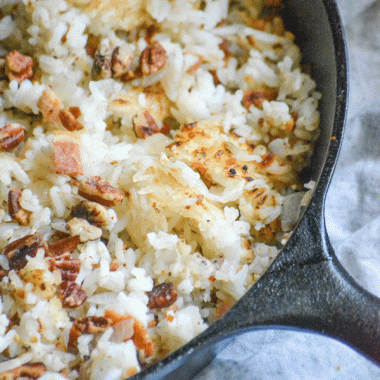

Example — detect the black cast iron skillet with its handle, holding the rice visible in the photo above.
[133,0,380,380]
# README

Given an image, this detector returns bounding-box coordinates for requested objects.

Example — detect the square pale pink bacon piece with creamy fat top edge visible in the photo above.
[53,131,83,176]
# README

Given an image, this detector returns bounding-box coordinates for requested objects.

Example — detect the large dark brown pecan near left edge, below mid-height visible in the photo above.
[3,233,47,270]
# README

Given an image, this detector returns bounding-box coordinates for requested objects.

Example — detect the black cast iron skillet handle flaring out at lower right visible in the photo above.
[211,205,380,364]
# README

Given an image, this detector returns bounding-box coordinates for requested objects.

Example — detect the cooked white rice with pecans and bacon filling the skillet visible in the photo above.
[0,0,320,380]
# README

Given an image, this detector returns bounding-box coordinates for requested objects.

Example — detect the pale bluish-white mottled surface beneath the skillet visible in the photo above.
[191,0,380,380]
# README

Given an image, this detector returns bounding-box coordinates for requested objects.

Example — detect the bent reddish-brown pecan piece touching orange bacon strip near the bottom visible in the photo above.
[68,316,111,350]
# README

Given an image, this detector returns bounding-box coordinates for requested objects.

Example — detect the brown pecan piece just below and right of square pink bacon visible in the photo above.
[78,176,123,207]
